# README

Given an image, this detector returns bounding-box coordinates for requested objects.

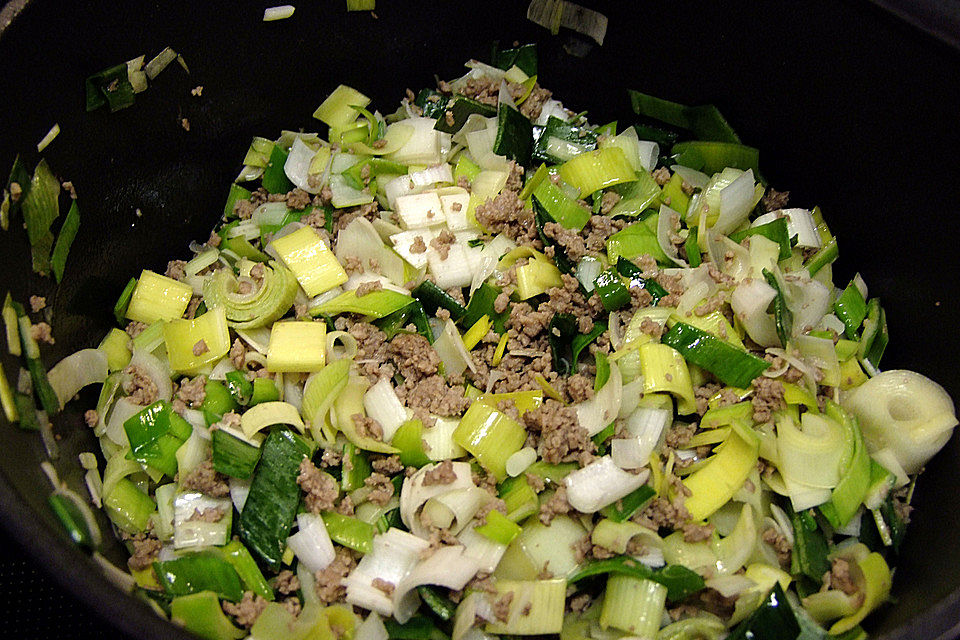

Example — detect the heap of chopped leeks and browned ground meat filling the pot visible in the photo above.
[4,46,957,640]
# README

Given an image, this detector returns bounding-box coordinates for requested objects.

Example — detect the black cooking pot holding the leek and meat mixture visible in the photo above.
[0,0,960,639]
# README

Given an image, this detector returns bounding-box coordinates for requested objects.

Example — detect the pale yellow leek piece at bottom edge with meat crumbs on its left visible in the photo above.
[486,579,567,635]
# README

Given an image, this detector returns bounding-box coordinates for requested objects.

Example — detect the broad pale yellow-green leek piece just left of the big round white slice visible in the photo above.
[777,413,855,489]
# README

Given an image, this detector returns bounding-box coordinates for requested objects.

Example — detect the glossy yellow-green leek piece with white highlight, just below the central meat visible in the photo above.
[453,402,527,480]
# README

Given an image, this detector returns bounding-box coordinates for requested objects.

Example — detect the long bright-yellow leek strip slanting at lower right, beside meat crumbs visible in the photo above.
[683,431,760,520]
